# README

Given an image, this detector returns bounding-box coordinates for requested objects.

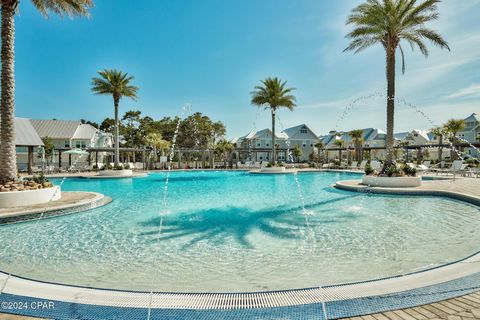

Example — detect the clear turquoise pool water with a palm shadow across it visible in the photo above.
[0,171,480,292]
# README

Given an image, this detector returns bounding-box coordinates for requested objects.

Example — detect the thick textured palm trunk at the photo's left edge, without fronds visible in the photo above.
[0,1,17,182]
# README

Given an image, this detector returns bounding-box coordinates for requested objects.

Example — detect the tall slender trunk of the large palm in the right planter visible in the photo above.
[384,47,395,168]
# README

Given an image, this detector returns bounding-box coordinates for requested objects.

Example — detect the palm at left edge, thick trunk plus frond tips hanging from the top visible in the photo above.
[0,0,93,182]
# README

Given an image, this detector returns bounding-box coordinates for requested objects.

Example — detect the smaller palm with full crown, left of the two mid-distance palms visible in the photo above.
[92,69,138,167]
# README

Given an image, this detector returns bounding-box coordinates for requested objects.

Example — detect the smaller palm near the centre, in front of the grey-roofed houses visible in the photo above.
[251,77,296,164]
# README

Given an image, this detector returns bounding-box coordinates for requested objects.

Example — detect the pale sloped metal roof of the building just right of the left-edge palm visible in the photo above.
[30,119,80,139]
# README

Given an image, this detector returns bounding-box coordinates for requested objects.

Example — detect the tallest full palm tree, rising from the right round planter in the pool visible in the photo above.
[344,0,450,170]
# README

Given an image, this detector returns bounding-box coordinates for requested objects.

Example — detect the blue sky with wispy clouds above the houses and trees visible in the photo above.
[16,0,480,137]
